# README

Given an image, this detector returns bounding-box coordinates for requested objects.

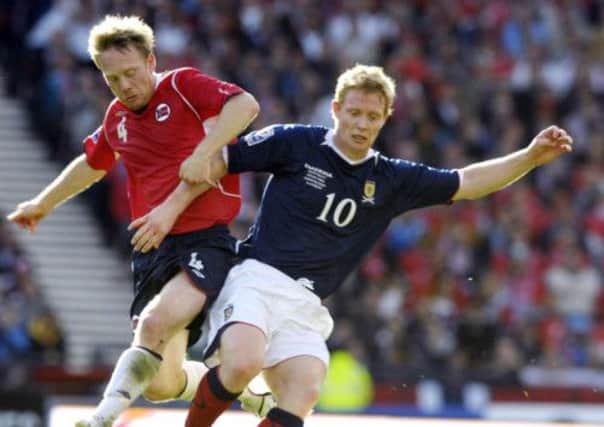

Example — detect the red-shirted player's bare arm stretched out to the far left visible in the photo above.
[7,154,106,231]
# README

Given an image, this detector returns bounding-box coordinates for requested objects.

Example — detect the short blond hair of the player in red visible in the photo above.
[88,15,155,67]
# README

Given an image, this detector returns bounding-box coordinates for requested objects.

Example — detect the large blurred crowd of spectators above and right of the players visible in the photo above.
[0,0,604,394]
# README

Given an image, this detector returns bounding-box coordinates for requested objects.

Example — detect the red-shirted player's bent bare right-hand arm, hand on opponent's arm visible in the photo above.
[180,92,260,184]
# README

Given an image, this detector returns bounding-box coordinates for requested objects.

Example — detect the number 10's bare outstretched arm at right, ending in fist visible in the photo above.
[453,126,573,200]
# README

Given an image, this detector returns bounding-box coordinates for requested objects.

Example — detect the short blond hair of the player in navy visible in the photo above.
[334,64,396,117]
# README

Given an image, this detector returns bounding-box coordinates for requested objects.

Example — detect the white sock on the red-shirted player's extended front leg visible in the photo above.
[93,347,161,425]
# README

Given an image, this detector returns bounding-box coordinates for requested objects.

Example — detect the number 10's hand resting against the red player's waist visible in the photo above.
[128,203,178,253]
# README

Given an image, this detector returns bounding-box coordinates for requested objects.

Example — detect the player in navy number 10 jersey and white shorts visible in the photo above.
[133,65,573,427]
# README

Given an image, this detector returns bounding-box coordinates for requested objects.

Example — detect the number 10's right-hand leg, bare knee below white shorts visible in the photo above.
[259,356,326,427]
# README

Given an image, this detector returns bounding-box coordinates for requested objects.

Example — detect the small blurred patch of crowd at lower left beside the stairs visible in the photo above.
[0,215,64,391]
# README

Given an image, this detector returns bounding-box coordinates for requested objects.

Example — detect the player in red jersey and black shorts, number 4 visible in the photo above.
[9,16,274,427]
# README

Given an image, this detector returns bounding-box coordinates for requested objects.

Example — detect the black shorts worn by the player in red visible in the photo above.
[130,225,237,347]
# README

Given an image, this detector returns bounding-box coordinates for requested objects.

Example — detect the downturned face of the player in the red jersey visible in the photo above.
[97,48,155,111]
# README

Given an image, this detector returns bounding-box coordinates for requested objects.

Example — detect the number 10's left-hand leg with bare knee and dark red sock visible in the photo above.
[185,323,266,427]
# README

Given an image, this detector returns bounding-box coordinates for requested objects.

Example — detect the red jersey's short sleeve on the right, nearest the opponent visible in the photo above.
[175,68,243,120]
